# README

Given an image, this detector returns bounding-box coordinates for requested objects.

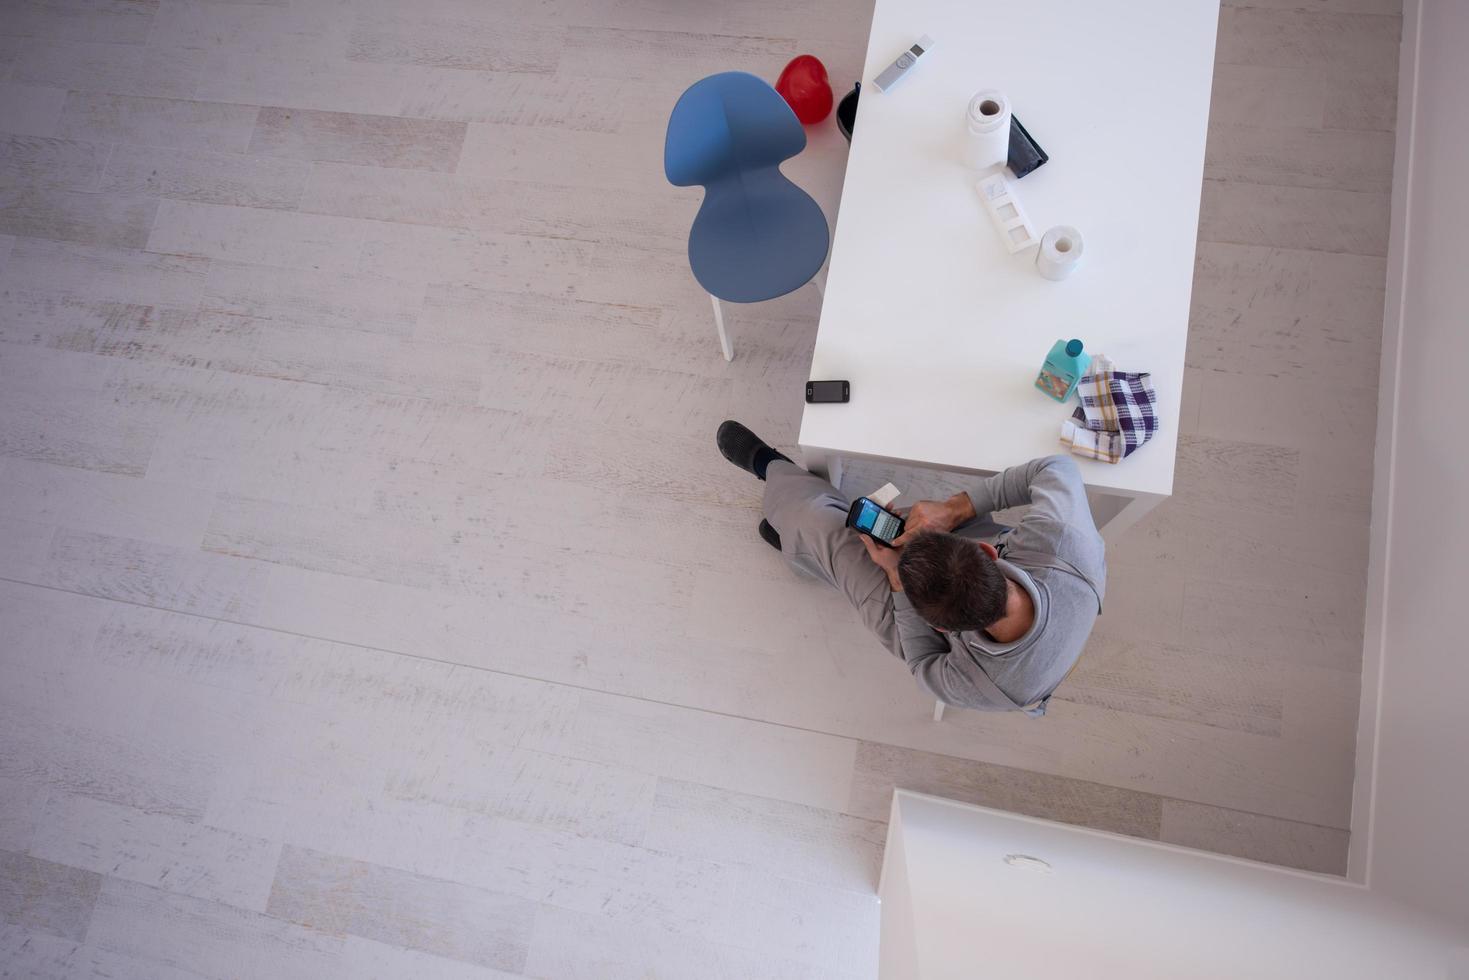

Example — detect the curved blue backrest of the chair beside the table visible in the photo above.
[663,72,806,187]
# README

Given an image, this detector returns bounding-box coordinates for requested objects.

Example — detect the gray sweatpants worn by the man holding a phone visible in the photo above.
[765,460,903,660]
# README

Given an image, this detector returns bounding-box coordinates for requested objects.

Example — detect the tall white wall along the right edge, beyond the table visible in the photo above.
[1353,0,1469,932]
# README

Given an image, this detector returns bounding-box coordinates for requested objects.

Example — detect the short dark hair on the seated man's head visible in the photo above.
[898,530,1009,632]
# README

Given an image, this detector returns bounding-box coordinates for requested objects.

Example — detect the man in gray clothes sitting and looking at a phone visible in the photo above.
[715,422,1106,716]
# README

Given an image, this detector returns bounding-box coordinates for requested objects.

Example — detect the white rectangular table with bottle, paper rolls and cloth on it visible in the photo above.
[799,0,1219,536]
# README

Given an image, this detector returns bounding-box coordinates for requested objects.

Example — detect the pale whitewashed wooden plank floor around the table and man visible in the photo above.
[0,0,1398,980]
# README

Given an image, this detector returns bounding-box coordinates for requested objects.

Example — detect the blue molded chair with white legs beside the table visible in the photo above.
[663,72,830,360]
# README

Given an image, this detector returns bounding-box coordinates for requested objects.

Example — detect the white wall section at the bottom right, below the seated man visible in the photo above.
[878,790,1469,980]
